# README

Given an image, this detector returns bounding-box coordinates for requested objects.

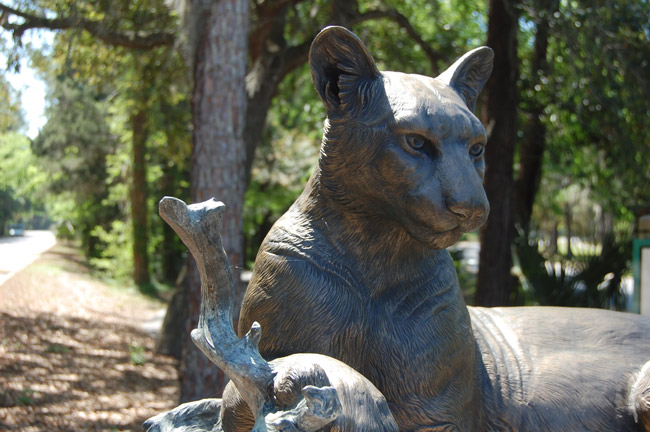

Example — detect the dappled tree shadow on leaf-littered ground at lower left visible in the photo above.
[0,313,177,431]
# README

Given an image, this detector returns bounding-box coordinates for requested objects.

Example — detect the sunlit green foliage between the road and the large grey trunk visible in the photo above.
[11,0,191,281]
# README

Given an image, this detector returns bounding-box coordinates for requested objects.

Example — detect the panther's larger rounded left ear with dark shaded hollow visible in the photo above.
[309,26,380,114]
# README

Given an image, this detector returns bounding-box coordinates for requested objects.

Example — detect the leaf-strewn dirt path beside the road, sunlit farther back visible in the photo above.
[0,241,178,432]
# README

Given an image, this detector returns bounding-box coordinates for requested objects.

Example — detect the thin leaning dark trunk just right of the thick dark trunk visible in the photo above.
[515,0,559,233]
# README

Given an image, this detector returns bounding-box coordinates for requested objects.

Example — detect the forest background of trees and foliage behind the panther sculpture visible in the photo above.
[0,0,650,400]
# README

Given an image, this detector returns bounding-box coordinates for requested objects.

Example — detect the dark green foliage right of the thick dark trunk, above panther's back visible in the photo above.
[515,1,650,309]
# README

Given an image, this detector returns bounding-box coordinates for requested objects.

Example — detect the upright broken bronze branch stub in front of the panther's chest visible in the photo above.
[159,197,273,418]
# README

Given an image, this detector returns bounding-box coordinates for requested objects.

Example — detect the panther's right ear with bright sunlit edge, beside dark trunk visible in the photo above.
[438,47,494,111]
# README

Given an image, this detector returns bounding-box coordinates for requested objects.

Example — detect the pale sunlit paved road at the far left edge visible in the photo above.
[0,231,56,285]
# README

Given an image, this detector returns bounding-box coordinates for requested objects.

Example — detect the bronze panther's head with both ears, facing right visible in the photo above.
[309,27,493,249]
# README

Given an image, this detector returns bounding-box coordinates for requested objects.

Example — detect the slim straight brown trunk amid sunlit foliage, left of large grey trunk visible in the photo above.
[131,108,151,288]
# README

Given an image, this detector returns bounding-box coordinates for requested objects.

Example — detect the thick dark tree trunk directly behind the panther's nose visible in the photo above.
[475,0,519,306]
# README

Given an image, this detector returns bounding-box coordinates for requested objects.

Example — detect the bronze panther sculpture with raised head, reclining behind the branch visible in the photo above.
[224,27,650,431]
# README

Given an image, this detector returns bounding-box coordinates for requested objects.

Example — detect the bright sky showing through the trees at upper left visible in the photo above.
[0,32,53,139]
